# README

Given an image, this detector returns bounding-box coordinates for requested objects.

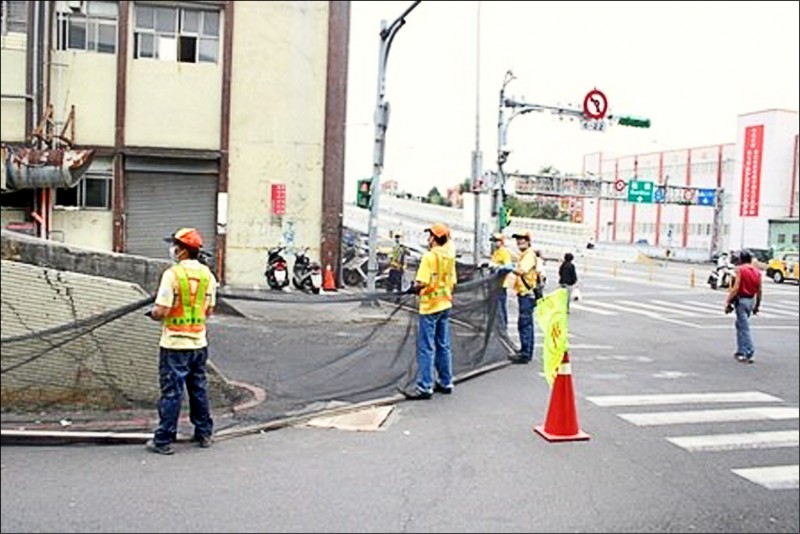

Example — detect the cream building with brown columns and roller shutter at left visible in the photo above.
[0,0,350,286]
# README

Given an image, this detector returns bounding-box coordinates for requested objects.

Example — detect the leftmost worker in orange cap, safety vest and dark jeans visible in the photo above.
[147,228,217,454]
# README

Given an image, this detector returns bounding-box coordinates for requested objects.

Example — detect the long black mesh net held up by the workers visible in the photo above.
[0,262,510,429]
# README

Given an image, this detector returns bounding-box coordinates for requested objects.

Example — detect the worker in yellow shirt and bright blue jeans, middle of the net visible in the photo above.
[403,223,456,400]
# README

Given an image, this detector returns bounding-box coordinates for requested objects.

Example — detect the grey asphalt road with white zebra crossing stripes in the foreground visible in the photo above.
[0,259,800,532]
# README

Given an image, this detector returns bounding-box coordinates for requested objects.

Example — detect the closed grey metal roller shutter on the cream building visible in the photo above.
[126,172,217,259]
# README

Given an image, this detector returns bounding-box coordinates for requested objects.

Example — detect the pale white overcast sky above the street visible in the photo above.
[345,0,800,201]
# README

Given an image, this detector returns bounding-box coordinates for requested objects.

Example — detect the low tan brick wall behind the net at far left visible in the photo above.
[0,260,234,412]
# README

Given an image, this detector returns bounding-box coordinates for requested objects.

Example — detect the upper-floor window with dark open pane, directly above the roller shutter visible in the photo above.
[133,4,219,63]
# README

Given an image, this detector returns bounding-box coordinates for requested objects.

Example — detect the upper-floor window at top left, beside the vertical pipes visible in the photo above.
[56,0,119,54]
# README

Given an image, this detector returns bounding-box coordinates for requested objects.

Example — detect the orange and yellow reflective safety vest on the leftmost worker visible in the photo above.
[164,265,210,333]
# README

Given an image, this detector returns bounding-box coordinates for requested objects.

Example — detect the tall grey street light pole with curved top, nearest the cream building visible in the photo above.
[367,0,421,291]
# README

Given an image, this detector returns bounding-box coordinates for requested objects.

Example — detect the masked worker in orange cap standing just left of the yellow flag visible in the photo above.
[509,231,539,364]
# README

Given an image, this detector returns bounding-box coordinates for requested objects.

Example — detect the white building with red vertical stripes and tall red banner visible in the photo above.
[583,110,800,253]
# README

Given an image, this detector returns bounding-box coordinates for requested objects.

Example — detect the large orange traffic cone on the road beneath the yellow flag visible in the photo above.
[533,352,589,441]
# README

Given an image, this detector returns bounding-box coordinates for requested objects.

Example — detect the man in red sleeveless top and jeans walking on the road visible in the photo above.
[725,249,761,363]
